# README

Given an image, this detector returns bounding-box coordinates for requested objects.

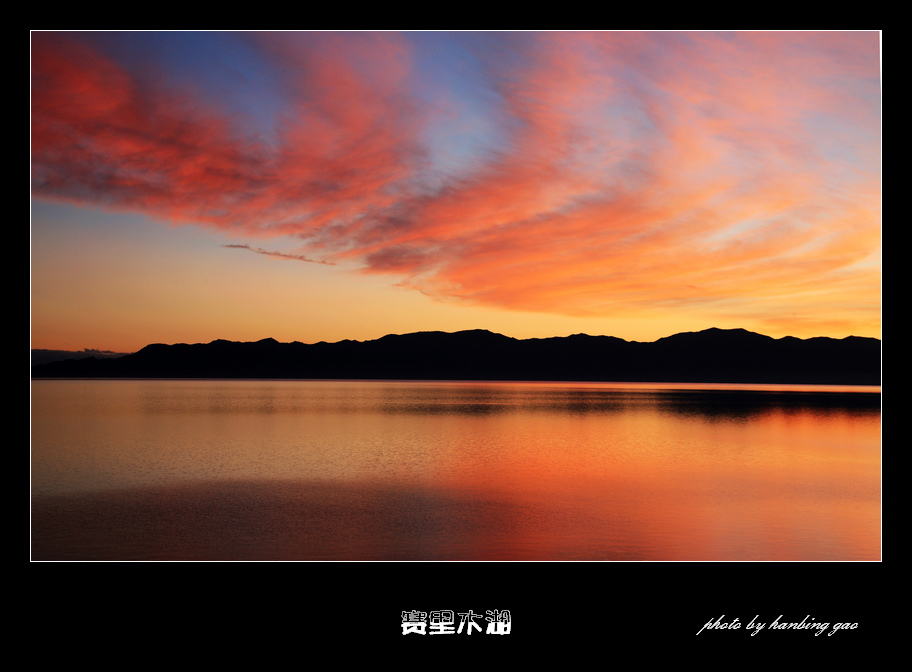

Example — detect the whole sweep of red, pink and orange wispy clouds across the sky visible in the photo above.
[32,33,881,330]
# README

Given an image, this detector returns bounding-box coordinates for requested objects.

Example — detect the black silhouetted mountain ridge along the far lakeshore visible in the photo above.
[32,328,881,385]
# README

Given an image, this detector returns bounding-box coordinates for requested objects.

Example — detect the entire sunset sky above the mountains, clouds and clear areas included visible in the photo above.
[31,31,882,352]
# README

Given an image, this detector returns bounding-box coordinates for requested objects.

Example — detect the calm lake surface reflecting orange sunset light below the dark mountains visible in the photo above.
[31,380,881,561]
